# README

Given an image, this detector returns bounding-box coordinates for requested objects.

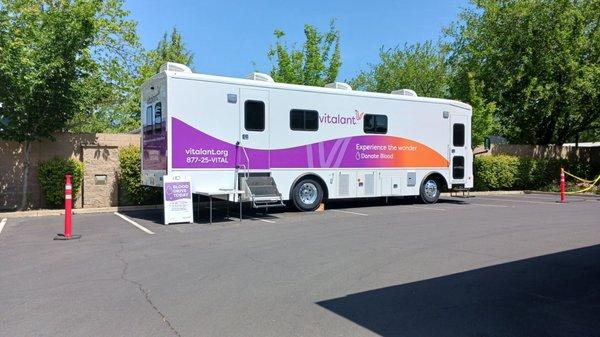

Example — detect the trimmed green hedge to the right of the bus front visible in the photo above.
[473,155,600,191]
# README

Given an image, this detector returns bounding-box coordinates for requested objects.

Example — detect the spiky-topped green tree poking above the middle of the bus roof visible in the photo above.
[268,20,342,87]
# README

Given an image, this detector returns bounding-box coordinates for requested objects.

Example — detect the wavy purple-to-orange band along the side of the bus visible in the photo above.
[171,118,448,169]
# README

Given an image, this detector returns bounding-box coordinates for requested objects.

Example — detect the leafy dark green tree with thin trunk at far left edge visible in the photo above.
[0,0,100,208]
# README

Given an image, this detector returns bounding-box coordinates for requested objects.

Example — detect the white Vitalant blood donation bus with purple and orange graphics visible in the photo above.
[141,63,473,211]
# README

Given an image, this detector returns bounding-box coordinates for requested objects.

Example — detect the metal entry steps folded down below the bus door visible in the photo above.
[241,176,285,208]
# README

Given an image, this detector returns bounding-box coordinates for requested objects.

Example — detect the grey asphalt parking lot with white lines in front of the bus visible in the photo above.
[0,194,600,337]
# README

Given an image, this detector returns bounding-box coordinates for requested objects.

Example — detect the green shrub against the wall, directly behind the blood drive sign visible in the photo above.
[118,145,162,205]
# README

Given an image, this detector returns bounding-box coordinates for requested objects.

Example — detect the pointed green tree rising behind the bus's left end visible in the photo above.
[122,28,194,122]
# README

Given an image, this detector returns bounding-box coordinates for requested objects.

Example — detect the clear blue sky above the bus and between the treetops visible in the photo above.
[126,0,468,81]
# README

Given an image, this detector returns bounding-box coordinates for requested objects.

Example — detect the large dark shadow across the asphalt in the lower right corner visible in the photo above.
[317,245,600,336]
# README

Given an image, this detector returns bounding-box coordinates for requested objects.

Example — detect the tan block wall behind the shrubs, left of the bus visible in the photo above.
[0,133,140,210]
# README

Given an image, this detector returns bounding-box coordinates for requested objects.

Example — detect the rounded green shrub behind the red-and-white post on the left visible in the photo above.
[38,157,84,208]
